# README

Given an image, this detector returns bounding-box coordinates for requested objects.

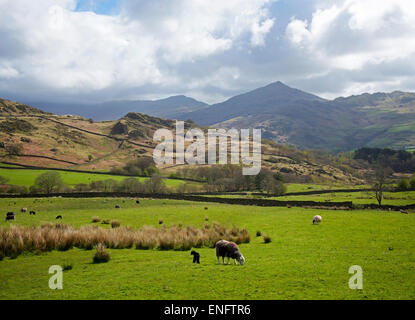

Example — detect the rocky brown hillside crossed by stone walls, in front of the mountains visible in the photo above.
[0,97,362,183]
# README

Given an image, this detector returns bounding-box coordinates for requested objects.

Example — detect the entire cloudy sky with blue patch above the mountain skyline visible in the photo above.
[0,0,415,103]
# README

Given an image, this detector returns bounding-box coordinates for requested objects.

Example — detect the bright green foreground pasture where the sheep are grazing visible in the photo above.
[0,198,415,299]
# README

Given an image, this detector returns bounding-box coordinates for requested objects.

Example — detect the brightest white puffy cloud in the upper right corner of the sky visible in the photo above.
[286,0,415,70]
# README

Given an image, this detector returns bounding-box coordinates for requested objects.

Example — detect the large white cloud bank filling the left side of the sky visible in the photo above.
[0,0,273,100]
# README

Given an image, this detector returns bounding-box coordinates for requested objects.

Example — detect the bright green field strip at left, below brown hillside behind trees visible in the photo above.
[0,168,191,187]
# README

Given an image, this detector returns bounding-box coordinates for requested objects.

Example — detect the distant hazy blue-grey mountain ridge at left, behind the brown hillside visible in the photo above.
[26,95,207,121]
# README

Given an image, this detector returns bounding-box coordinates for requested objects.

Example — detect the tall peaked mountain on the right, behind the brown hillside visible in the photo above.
[179,82,415,152]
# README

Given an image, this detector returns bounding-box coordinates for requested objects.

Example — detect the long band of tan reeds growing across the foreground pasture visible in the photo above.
[0,223,250,258]
